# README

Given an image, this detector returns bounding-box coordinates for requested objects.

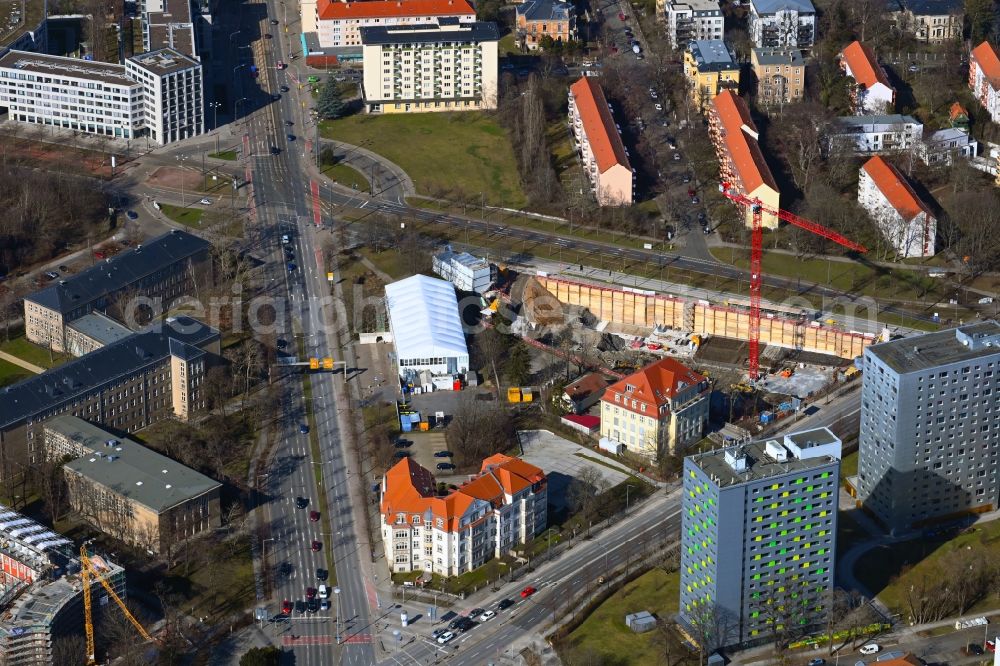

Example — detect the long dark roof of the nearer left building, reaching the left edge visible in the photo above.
[0,317,219,428]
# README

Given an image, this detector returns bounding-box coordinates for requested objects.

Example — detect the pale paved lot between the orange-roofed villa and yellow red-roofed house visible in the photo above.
[518,430,628,512]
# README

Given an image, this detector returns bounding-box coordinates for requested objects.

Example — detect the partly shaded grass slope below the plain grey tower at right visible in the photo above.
[854,521,1000,613]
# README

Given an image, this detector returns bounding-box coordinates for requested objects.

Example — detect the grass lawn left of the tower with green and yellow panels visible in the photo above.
[566,569,680,665]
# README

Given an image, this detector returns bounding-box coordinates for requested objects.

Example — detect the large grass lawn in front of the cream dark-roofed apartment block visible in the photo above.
[322,112,526,208]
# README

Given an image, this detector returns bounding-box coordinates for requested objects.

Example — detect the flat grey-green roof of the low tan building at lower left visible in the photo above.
[54,416,222,513]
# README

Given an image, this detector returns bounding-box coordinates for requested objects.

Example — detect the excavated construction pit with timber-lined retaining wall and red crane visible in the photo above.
[504,274,876,424]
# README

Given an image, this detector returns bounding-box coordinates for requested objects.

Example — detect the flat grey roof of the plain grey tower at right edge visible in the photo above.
[868,321,1000,374]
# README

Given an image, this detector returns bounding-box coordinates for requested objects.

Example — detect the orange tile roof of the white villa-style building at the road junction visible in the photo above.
[381,454,545,532]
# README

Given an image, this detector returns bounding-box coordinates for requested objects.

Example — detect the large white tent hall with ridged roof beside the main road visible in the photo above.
[385,275,469,377]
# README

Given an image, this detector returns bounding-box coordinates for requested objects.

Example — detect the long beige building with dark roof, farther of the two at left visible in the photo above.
[24,229,212,351]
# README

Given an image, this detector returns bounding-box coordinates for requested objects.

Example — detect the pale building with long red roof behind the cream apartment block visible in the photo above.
[316,0,476,53]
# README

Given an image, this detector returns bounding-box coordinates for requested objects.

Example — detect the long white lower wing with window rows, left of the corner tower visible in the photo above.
[0,51,145,139]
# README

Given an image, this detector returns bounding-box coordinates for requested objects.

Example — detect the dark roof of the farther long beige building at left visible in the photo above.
[24,229,211,314]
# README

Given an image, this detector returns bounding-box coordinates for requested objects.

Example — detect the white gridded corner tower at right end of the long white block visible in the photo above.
[125,48,205,146]
